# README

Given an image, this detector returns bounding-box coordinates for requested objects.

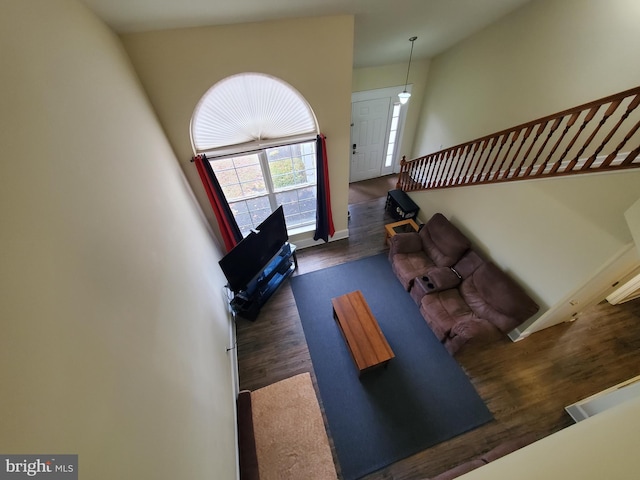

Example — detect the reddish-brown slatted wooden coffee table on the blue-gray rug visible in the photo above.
[331,290,395,375]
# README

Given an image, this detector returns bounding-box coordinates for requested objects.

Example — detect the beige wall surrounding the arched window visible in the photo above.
[122,16,353,244]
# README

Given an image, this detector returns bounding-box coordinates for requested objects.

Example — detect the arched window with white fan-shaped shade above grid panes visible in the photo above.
[191,73,319,235]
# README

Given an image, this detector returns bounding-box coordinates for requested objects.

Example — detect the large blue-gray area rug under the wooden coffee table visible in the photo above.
[291,254,493,480]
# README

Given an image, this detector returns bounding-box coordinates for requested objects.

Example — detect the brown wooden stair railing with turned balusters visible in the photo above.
[397,87,640,191]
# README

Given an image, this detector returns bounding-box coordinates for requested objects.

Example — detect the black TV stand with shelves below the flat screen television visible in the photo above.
[231,242,298,321]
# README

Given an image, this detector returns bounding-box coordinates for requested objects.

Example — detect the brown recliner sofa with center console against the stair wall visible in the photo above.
[389,213,539,354]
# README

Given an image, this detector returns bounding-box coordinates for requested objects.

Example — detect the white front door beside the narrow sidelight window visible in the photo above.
[349,97,391,182]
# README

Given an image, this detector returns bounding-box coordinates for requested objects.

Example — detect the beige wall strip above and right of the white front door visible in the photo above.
[351,59,430,159]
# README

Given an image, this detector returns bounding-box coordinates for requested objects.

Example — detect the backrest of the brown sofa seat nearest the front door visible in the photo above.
[420,213,471,267]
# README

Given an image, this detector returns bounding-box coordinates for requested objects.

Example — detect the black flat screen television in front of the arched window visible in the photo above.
[218,205,289,292]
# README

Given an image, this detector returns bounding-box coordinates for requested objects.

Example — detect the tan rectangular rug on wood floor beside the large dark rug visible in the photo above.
[251,373,337,480]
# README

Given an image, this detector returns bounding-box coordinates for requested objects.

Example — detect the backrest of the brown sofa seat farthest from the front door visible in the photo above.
[460,262,538,333]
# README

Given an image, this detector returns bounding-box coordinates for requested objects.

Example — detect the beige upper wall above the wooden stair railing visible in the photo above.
[416,0,640,155]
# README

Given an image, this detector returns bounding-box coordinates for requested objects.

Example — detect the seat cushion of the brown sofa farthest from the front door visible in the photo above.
[420,288,473,342]
